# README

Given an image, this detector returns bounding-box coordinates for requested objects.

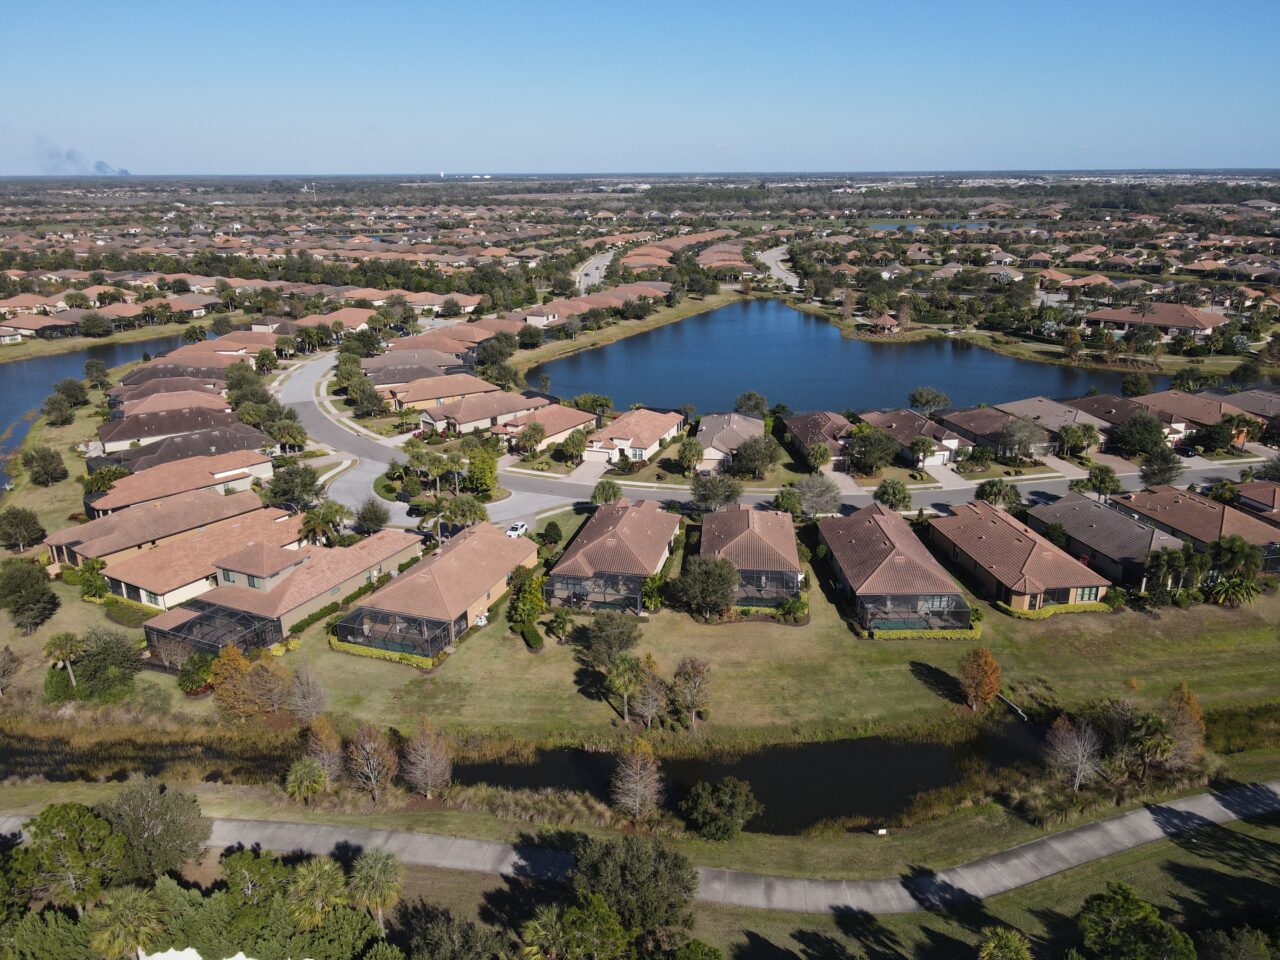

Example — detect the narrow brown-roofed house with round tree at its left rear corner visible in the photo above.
[699,503,804,605]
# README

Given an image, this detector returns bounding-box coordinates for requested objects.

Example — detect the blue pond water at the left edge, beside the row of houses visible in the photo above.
[0,334,182,484]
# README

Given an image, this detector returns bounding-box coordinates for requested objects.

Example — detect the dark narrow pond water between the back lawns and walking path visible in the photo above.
[453,724,1039,833]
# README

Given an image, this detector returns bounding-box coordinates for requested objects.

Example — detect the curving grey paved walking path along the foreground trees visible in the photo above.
[0,780,1280,914]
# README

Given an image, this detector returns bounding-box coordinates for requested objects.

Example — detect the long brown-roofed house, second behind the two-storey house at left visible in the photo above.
[45,490,262,567]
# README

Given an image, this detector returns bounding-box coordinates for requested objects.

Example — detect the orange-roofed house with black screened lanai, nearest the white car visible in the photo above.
[334,524,538,657]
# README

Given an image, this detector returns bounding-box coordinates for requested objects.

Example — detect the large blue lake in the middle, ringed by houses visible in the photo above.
[529,300,1158,413]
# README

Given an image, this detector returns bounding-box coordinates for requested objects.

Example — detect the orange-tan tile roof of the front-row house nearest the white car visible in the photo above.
[360,524,538,621]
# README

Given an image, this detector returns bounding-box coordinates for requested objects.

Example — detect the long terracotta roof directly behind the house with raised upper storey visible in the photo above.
[106,508,302,594]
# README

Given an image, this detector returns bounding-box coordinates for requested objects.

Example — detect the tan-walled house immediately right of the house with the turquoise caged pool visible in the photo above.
[929,500,1110,611]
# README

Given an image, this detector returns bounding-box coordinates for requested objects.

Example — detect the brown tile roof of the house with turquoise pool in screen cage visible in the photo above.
[818,503,960,596]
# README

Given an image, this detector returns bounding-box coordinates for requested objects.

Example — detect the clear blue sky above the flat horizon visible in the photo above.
[0,0,1280,174]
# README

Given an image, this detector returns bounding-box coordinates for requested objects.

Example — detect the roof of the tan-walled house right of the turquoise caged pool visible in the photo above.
[929,500,1110,594]
